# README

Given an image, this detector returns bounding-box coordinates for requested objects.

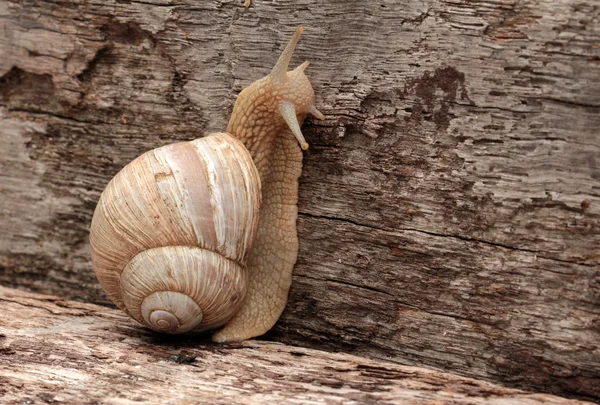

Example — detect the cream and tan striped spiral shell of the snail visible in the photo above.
[90,133,261,333]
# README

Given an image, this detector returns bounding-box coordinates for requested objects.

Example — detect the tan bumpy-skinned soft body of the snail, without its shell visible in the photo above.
[213,27,324,342]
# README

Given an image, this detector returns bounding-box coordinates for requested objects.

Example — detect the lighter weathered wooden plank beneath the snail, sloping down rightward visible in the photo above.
[0,287,584,405]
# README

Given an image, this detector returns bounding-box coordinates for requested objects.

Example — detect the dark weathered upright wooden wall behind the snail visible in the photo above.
[0,0,600,400]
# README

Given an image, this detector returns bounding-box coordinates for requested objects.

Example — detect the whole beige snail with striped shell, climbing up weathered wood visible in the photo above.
[90,26,325,342]
